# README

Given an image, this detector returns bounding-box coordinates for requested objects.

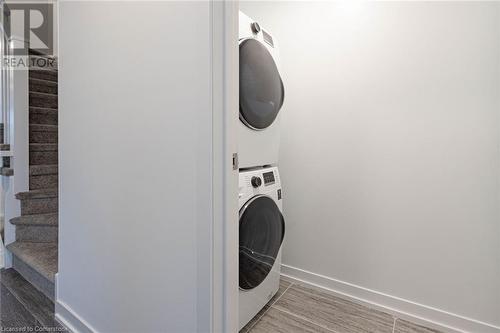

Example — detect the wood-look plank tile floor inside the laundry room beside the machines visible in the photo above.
[240,278,440,333]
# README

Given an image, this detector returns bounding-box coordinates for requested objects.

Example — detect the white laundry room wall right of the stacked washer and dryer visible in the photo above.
[240,2,500,332]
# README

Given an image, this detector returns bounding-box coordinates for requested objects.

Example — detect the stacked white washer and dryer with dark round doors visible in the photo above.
[238,12,285,329]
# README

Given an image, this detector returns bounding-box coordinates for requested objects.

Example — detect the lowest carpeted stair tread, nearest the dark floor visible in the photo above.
[7,242,57,283]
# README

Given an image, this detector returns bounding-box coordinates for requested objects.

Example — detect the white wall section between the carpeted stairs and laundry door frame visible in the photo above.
[56,1,212,333]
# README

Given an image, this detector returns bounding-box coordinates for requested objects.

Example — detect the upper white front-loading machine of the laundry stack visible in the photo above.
[238,12,285,168]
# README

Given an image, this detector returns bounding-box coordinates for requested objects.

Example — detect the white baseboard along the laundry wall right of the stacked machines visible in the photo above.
[281,265,500,333]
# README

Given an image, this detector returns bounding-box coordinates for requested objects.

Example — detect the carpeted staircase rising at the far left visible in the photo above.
[7,53,58,300]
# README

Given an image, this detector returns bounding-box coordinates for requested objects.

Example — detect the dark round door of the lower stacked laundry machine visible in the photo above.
[239,195,285,290]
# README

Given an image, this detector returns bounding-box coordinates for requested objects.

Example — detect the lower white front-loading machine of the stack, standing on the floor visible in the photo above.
[239,167,285,330]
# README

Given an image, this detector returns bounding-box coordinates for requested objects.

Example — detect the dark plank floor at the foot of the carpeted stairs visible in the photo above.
[0,268,67,332]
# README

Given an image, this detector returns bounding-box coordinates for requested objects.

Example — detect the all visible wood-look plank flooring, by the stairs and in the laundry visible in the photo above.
[0,269,446,333]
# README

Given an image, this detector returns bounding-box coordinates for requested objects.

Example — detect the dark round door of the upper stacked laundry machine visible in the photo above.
[240,38,285,130]
